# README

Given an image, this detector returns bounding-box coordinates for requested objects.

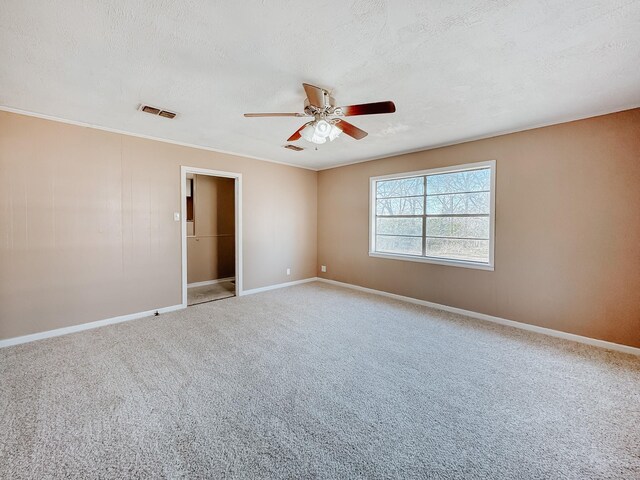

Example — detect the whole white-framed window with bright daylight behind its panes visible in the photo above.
[369,160,496,270]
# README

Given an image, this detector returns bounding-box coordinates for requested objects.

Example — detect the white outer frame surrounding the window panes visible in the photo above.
[369,160,496,271]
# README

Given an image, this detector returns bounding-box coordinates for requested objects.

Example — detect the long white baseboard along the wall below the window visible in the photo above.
[318,278,640,356]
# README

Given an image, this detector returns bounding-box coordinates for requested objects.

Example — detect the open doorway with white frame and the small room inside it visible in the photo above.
[181,167,242,306]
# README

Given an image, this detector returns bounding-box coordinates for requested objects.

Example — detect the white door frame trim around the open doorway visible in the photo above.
[180,165,242,308]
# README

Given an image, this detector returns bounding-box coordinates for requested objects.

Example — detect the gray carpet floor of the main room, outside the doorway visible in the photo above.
[0,283,640,479]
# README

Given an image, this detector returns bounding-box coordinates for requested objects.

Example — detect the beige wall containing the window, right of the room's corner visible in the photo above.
[318,109,640,347]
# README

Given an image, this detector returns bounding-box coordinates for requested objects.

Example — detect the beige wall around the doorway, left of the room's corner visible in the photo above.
[0,112,317,338]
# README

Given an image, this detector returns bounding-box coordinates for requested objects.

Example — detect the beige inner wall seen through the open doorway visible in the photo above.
[187,175,235,283]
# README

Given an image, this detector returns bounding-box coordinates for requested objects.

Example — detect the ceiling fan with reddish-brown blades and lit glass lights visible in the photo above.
[244,83,396,144]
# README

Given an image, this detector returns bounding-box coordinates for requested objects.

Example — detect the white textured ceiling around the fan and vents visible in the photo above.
[0,0,640,168]
